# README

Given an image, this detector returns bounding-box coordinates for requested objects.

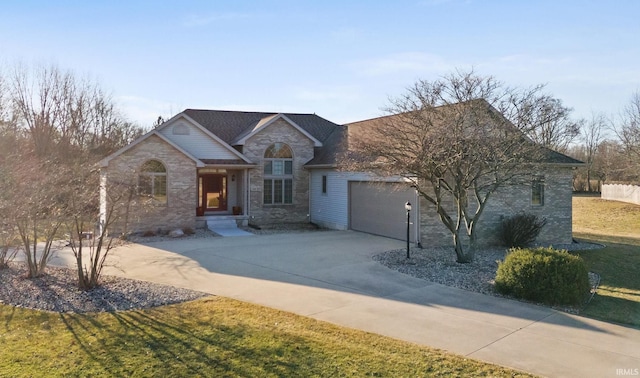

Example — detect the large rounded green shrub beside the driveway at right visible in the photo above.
[495,248,590,305]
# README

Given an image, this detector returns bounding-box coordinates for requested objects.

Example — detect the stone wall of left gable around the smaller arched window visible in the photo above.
[103,135,198,232]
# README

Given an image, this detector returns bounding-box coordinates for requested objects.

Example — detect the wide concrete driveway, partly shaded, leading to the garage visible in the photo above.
[51,231,640,377]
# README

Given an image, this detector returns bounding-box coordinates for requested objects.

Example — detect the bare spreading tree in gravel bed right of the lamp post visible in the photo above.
[341,72,544,263]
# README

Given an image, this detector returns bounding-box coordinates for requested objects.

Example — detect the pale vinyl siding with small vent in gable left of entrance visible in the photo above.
[159,119,238,159]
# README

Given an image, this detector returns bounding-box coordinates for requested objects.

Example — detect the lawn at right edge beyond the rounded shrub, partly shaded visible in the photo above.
[573,197,640,328]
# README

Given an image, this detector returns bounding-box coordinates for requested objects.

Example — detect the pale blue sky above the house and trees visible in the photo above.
[0,0,640,126]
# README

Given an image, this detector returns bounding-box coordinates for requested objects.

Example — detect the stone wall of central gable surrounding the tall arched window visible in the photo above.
[243,119,314,225]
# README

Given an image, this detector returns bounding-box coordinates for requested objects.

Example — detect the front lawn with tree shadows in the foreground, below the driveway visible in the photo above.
[0,297,528,377]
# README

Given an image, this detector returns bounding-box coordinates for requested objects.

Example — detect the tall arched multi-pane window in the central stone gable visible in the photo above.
[263,143,293,205]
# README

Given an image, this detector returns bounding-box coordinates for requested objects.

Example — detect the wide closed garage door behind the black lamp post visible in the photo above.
[349,181,416,241]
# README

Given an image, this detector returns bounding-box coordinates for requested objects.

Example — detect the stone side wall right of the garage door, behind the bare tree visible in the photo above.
[420,166,573,246]
